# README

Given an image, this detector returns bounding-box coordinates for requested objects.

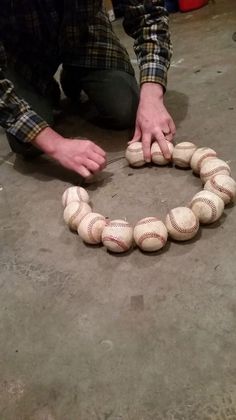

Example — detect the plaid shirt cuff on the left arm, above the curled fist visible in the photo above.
[7,110,48,143]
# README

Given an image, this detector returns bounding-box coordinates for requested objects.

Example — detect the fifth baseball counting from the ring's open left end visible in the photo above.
[134,217,168,252]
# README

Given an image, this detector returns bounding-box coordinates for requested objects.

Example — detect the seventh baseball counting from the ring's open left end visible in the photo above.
[190,190,224,224]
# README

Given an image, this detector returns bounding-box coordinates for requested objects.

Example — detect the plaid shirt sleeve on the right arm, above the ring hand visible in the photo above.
[124,0,172,89]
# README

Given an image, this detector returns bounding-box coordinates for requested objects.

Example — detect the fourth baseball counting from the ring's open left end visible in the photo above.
[102,220,133,253]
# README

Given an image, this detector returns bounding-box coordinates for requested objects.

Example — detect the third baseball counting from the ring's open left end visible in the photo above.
[78,213,107,244]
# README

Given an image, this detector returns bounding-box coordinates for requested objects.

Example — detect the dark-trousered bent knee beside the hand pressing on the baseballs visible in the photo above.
[61,66,139,129]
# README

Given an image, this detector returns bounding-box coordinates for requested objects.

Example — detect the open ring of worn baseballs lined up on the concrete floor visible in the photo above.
[62,142,236,253]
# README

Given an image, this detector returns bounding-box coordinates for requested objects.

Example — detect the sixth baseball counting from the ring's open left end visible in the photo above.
[165,207,199,241]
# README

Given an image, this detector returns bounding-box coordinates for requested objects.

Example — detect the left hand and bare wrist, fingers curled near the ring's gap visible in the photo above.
[33,127,106,178]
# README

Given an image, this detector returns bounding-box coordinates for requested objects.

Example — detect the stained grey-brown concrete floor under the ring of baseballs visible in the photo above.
[0,0,236,420]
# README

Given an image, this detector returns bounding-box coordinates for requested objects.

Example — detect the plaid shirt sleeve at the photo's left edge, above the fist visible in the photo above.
[0,41,48,142]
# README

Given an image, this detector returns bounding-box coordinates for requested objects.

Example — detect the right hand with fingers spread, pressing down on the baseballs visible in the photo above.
[130,83,176,162]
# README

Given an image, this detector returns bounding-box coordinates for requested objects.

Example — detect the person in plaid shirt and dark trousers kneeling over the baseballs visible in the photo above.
[0,0,175,177]
